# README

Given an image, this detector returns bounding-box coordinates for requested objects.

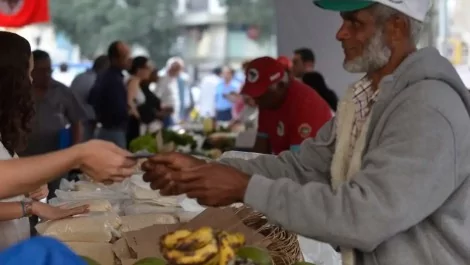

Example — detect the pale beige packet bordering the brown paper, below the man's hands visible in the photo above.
[121,213,178,233]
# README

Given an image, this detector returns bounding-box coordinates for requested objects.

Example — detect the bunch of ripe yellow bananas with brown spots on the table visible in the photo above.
[160,227,245,265]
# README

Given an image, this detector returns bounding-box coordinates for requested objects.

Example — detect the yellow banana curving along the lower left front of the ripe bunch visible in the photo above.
[162,238,219,265]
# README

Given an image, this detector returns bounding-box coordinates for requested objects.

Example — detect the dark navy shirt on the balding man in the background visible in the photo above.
[89,67,129,130]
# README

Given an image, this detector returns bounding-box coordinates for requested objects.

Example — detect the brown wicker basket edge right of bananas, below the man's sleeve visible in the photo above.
[235,206,303,265]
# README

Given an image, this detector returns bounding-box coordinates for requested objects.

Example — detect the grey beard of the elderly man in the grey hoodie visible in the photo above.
[343,30,392,73]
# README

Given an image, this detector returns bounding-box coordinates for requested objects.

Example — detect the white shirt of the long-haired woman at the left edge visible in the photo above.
[0,142,30,251]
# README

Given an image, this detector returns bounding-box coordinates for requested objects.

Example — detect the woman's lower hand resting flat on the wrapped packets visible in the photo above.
[32,202,89,220]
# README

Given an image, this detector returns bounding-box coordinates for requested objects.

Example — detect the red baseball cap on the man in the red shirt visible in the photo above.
[241,57,286,98]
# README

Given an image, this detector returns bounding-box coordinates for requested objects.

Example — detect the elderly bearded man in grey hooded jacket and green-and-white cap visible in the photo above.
[145,0,470,265]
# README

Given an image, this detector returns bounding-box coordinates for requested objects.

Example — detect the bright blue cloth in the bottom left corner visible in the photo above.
[0,237,86,265]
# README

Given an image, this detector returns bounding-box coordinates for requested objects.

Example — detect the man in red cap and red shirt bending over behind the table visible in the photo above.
[241,57,332,154]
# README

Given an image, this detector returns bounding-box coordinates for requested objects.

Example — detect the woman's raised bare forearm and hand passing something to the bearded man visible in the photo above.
[0,141,136,199]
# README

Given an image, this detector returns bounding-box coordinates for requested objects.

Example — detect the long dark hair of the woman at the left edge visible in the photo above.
[0,31,34,154]
